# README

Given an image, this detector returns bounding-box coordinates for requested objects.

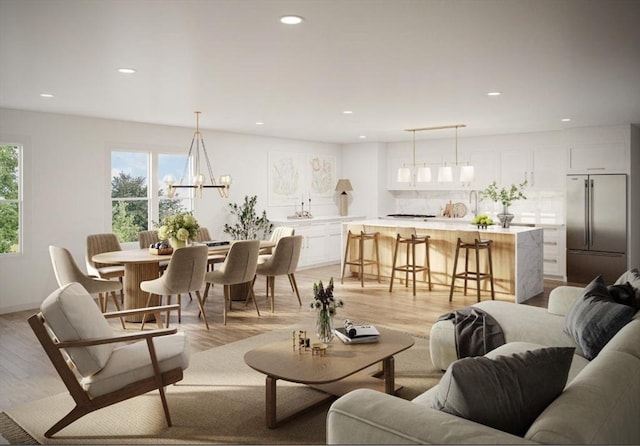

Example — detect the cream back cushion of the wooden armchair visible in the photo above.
[40,282,114,376]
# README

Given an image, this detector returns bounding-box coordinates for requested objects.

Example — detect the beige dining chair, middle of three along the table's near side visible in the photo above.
[201,240,260,325]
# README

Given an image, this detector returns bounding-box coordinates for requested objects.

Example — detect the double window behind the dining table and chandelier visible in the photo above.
[111,151,192,242]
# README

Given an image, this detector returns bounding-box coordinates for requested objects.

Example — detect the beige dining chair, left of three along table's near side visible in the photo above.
[140,245,209,330]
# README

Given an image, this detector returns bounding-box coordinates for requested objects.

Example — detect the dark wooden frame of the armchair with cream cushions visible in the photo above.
[28,305,183,438]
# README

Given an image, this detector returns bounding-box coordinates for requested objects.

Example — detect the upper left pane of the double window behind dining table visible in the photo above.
[111,152,149,198]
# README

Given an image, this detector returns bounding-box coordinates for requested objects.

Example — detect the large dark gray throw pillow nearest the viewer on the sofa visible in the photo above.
[432,347,575,436]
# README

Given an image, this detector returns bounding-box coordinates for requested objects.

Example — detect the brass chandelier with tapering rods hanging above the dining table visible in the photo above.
[164,111,231,198]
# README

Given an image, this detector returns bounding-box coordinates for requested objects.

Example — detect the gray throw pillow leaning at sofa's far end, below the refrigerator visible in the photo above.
[564,276,635,360]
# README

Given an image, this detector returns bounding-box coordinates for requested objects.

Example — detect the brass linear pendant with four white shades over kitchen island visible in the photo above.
[398,124,474,183]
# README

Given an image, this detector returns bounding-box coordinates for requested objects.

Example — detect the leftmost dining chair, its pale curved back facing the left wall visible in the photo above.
[49,246,126,329]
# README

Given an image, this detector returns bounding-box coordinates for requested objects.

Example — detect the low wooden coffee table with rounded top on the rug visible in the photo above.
[244,328,414,429]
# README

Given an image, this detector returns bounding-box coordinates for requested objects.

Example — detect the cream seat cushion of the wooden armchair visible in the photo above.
[81,332,189,398]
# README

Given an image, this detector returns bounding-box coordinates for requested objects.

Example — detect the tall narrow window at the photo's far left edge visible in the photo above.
[0,143,22,254]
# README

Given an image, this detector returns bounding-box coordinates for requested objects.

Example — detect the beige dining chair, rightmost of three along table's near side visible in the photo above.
[254,235,302,312]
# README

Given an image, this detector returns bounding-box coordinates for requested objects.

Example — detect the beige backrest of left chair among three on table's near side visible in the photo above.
[160,245,209,294]
